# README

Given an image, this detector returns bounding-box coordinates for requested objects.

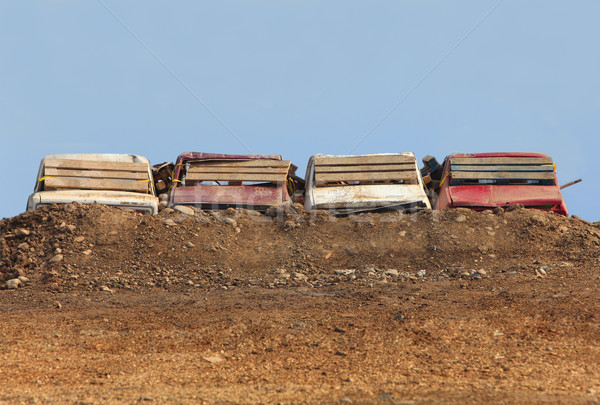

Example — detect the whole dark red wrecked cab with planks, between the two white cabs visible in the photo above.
[168,152,293,211]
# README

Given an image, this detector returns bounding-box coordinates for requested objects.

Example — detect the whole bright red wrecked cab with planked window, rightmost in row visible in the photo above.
[435,152,568,216]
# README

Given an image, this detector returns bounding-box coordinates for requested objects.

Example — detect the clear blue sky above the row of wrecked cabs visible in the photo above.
[0,0,600,221]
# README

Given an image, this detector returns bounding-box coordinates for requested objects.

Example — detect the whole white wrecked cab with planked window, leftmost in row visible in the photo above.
[27,154,158,214]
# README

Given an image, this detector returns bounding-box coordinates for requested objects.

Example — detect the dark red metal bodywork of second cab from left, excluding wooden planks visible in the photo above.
[169,152,291,210]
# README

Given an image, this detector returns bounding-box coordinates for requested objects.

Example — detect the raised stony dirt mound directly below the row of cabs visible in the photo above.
[0,203,600,291]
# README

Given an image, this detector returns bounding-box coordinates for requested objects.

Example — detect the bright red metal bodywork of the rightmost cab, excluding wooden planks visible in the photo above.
[435,152,568,216]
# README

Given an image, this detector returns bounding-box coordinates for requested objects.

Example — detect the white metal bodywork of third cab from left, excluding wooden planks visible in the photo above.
[304,152,431,214]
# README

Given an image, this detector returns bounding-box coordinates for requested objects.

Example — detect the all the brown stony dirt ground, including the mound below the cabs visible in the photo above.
[0,204,600,404]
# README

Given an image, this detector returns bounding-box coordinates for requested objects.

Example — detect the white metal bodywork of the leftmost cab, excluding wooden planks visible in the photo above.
[27,153,158,214]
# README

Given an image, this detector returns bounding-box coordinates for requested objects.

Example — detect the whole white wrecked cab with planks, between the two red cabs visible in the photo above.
[304,152,431,215]
